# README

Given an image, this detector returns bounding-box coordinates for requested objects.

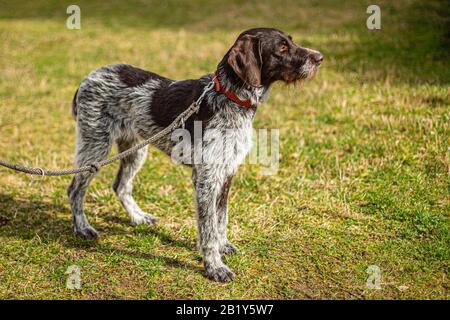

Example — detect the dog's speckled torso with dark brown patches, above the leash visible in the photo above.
[72,64,219,154]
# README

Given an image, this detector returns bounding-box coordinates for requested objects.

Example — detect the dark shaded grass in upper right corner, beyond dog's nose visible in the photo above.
[324,0,450,86]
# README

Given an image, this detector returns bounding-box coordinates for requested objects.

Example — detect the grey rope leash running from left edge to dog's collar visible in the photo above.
[0,80,214,178]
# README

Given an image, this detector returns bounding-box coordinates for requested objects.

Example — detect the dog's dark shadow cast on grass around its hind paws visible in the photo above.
[0,194,201,271]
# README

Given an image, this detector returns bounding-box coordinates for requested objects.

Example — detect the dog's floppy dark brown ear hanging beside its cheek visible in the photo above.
[228,34,262,87]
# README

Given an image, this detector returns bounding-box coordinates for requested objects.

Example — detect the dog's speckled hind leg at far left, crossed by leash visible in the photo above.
[67,134,111,240]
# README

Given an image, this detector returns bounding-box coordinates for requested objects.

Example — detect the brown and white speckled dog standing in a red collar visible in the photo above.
[68,28,323,282]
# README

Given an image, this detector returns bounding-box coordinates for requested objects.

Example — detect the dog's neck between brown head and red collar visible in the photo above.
[216,66,269,106]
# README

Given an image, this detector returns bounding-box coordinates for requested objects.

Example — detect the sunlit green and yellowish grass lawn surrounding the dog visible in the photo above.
[0,0,450,299]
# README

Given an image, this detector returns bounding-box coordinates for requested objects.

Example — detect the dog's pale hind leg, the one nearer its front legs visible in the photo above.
[113,140,157,225]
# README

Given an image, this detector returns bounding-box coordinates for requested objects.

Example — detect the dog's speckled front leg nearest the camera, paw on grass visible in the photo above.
[192,166,234,282]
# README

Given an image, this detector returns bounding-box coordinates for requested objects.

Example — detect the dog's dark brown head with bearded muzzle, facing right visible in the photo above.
[219,28,323,87]
